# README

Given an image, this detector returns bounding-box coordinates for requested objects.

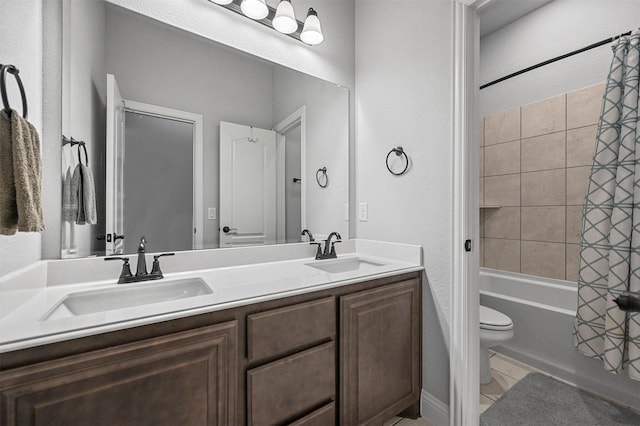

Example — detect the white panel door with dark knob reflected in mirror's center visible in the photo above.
[220,121,276,247]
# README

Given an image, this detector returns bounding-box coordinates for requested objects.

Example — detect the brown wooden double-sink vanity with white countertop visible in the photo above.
[0,241,422,426]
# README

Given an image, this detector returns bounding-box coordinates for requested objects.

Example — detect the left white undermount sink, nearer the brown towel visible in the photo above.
[42,278,213,320]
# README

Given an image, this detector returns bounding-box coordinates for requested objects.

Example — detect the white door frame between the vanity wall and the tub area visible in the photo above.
[449,0,480,426]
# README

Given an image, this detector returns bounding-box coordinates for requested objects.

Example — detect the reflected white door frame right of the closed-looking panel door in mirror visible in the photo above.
[273,105,307,243]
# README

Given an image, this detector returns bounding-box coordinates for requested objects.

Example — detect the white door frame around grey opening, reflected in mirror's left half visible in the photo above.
[124,99,204,249]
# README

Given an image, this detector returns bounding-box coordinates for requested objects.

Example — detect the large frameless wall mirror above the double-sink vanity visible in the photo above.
[61,0,349,258]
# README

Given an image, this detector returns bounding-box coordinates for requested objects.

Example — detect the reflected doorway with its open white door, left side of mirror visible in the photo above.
[105,74,203,255]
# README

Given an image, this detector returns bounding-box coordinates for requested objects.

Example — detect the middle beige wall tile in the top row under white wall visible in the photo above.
[521,95,566,139]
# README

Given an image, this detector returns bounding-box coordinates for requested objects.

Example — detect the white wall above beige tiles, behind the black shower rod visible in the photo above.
[479,0,640,116]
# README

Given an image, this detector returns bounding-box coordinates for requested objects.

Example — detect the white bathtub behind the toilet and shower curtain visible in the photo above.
[479,268,640,410]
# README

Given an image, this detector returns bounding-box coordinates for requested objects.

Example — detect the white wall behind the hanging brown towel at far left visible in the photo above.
[0,0,43,276]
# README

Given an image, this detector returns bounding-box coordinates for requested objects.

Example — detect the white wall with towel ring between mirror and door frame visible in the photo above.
[355,0,453,404]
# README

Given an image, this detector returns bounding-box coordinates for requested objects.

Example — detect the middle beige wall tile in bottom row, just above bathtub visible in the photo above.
[521,241,566,280]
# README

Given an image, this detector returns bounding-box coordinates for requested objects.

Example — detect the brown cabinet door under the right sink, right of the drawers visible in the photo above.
[340,279,421,425]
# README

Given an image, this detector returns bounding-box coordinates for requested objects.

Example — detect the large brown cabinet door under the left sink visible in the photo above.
[0,321,238,426]
